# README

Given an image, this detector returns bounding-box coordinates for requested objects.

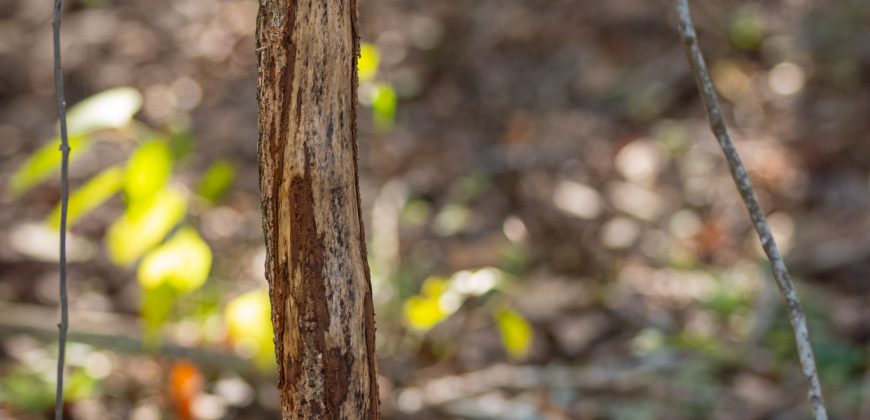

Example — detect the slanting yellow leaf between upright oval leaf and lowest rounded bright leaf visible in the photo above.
[106,187,187,265]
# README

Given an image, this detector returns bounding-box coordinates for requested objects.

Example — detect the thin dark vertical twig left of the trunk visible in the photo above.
[52,0,69,420]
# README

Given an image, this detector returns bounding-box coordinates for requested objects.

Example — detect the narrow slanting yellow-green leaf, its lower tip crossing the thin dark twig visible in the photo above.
[48,166,124,229]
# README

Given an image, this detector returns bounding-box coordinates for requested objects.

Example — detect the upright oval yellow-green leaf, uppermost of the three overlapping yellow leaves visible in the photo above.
[124,139,172,206]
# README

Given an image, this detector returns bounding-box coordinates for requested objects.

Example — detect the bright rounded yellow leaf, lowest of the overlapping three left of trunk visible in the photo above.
[138,228,212,293]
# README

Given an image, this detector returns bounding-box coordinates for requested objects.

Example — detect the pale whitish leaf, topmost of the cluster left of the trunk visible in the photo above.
[67,87,142,135]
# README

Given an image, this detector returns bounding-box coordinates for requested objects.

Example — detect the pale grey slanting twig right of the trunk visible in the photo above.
[675,0,828,420]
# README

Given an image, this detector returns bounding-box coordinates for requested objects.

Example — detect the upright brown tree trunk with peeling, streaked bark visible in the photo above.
[257,0,379,419]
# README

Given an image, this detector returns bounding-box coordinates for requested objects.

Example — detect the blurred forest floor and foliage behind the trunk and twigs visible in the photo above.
[0,0,870,420]
